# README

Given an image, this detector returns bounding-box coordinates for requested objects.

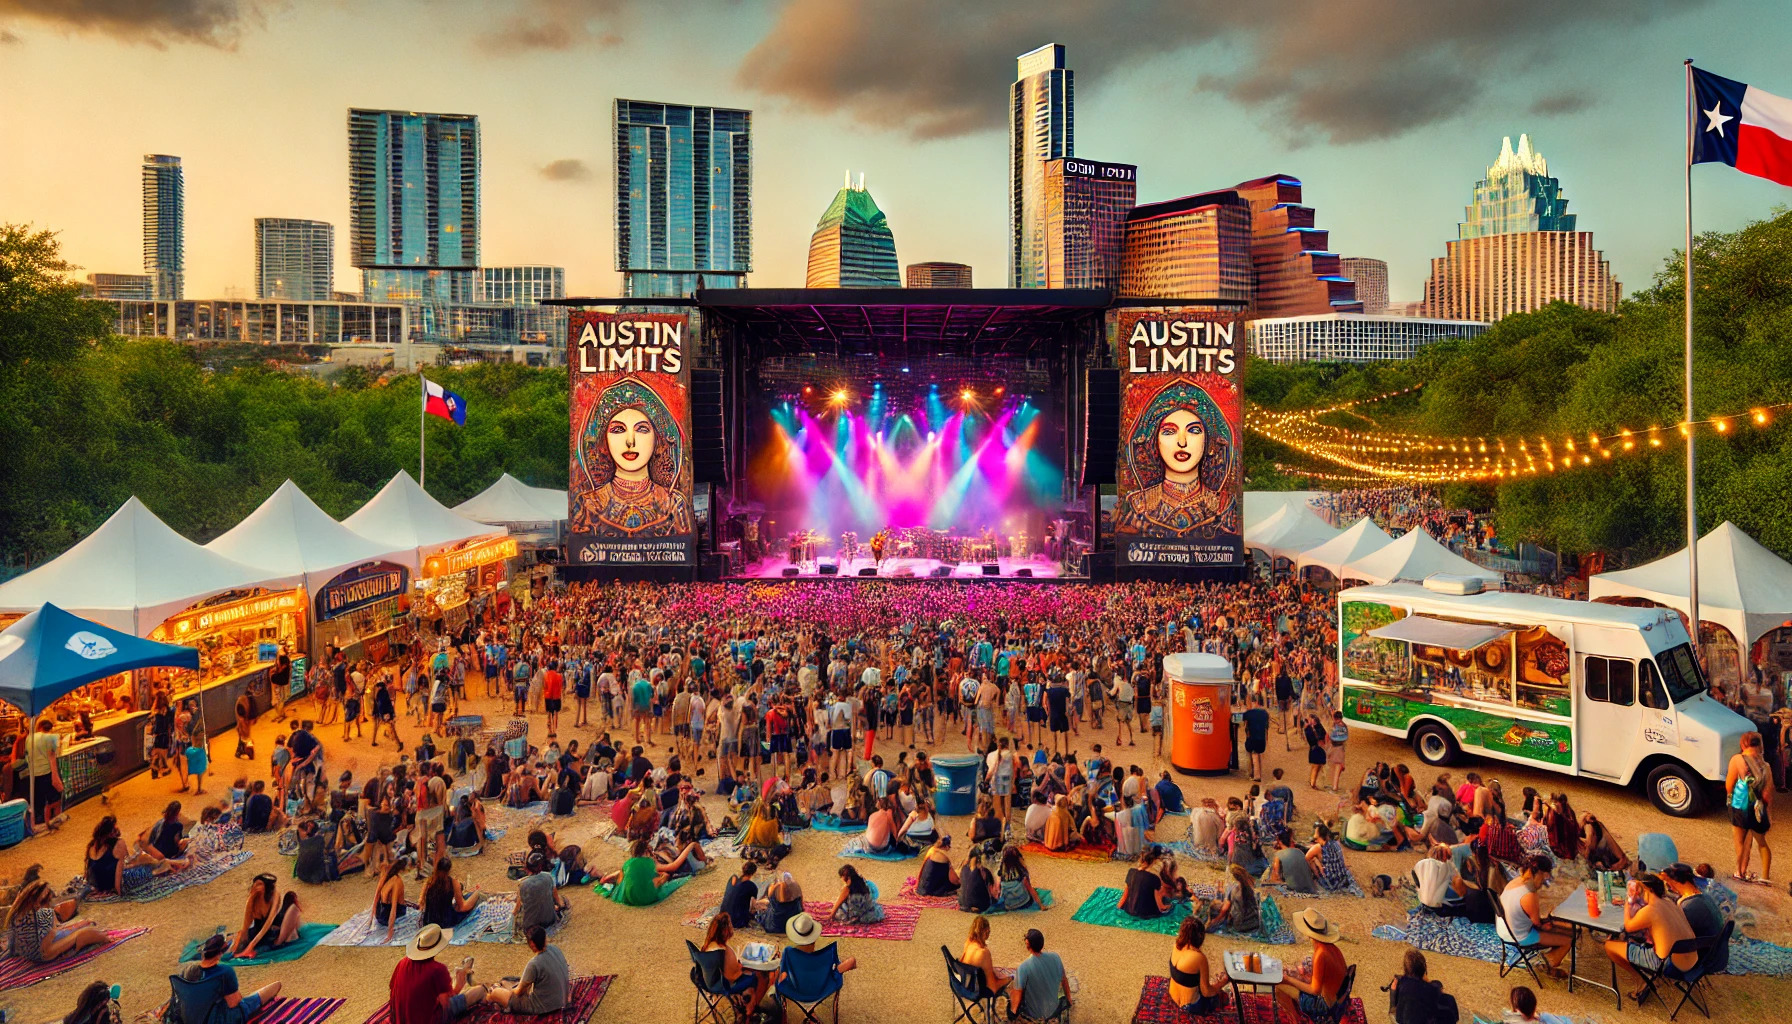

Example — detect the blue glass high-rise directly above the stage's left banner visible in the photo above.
[615,99,753,298]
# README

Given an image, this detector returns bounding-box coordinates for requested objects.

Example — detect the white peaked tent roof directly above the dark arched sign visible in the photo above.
[206,481,418,584]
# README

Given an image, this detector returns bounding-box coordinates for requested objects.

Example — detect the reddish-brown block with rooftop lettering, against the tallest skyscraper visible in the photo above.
[1036,158,1138,289]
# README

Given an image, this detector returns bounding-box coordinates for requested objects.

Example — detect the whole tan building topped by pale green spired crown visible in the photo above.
[1421,135,1622,323]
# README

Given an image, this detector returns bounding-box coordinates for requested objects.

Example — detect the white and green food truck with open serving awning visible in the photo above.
[1339,576,1754,818]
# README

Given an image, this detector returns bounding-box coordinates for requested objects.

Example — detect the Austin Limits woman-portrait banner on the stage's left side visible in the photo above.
[566,310,695,565]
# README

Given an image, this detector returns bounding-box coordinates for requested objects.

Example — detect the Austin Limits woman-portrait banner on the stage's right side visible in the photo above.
[1107,307,1244,568]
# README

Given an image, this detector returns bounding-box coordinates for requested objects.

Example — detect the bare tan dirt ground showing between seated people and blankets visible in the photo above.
[0,680,1792,1024]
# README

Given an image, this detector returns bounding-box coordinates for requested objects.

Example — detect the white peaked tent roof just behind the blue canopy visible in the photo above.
[0,497,299,637]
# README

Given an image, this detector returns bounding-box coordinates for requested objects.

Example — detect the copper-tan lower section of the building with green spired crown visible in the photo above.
[1421,231,1622,323]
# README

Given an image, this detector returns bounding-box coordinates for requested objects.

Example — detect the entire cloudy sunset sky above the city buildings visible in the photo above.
[0,0,1792,299]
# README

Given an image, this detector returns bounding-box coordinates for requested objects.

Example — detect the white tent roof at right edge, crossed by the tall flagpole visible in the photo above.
[1588,520,1792,647]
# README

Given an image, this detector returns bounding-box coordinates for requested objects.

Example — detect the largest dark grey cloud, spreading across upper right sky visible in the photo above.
[738,0,1706,142]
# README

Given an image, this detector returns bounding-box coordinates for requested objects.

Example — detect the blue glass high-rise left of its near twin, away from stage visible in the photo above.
[348,109,480,305]
